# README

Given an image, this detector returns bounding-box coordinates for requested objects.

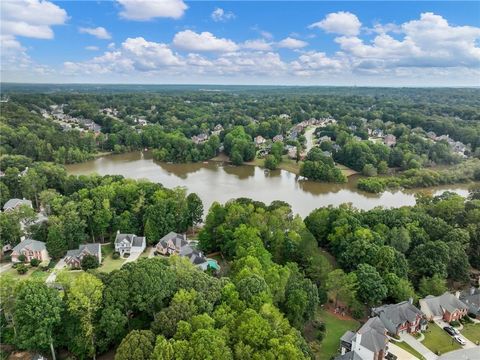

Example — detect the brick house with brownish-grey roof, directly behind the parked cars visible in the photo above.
[420,292,468,322]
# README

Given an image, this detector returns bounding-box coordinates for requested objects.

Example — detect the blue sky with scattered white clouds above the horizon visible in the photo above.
[0,0,480,86]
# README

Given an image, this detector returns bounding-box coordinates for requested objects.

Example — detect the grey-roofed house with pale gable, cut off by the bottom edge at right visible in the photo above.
[335,317,388,360]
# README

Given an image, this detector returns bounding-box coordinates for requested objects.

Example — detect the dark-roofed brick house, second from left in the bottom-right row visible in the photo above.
[372,299,427,335]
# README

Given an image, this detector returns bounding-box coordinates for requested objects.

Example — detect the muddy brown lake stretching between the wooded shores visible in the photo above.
[67,152,468,216]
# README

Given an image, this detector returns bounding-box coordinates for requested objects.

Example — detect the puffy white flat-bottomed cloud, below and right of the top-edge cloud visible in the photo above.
[173,30,238,52]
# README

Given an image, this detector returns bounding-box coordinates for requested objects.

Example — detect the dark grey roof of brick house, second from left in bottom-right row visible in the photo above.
[372,301,423,333]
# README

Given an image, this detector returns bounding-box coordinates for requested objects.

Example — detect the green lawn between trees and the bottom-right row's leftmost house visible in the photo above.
[314,309,360,360]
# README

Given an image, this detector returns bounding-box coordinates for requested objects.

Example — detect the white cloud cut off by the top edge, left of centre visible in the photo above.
[117,0,188,21]
